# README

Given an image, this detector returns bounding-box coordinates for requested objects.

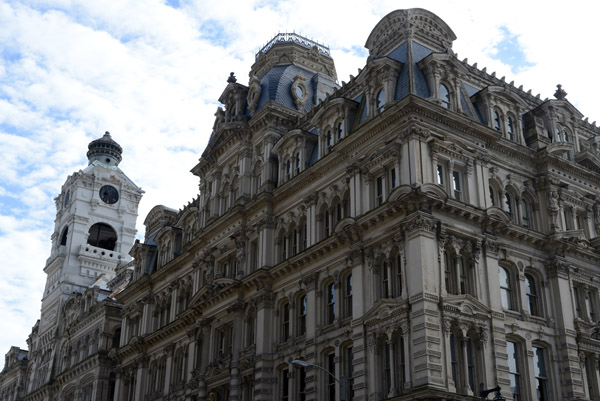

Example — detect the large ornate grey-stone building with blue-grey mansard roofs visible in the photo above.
[113,9,600,401]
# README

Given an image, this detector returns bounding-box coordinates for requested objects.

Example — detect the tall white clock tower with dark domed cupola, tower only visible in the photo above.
[38,132,143,334]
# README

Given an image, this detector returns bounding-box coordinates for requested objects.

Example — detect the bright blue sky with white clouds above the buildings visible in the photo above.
[0,0,600,354]
